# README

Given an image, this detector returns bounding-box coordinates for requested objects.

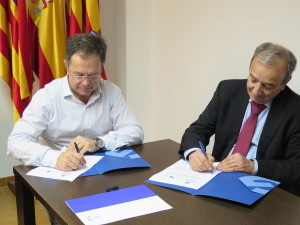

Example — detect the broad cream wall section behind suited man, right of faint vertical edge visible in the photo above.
[148,0,300,148]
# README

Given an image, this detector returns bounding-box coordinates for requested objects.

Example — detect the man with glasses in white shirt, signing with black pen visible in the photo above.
[8,33,144,171]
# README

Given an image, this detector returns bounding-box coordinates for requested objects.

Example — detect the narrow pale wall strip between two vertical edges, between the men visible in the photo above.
[125,0,154,141]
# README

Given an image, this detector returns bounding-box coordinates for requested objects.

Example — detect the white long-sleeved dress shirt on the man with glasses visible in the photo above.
[7,76,144,167]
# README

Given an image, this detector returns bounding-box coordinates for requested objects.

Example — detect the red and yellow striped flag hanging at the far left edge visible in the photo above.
[0,0,33,121]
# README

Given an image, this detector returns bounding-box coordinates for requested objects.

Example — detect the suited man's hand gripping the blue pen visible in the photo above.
[189,150,215,172]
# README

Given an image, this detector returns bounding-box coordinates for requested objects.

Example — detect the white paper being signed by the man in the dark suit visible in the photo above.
[149,159,221,190]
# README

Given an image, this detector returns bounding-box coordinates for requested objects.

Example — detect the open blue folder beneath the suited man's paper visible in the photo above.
[145,172,279,205]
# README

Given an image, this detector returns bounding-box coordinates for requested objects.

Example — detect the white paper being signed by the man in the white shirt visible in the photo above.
[26,156,103,181]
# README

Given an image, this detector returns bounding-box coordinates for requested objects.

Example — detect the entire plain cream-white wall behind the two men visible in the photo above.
[0,0,300,177]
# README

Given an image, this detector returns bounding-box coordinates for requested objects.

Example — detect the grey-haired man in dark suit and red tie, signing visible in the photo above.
[179,43,300,196]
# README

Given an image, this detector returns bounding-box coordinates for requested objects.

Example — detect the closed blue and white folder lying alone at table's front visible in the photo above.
[66,185,172,225]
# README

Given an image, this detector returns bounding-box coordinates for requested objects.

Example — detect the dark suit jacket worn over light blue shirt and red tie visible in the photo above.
[179,80,300,196]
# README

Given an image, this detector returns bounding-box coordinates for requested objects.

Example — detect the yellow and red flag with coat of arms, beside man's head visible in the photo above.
[28,0,66,87]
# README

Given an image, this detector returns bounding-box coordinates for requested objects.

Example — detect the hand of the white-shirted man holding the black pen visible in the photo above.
[55,145,86,171]
